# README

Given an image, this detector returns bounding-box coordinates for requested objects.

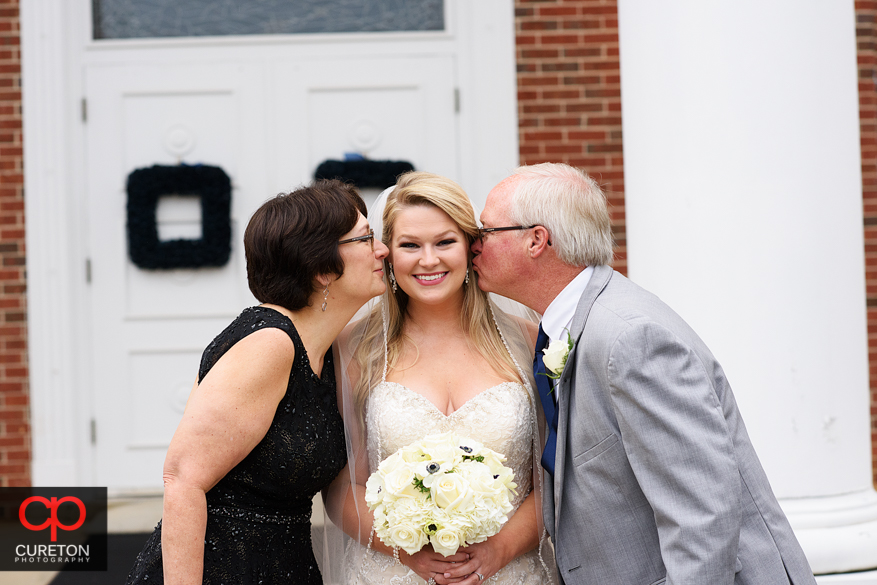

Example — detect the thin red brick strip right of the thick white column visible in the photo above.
[856,0,877,485]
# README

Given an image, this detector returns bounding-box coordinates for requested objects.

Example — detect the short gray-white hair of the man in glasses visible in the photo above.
[509,163,614,266]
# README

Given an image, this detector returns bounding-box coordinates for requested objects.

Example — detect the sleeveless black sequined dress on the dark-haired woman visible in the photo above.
[127,307,347,585]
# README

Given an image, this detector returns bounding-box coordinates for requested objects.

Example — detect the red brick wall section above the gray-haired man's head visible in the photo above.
[515,0,627,273]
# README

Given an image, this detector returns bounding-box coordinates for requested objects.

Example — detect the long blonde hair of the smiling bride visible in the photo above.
[353,171,523,412]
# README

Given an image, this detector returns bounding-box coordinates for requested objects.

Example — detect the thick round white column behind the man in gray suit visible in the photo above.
[619,0,877,584]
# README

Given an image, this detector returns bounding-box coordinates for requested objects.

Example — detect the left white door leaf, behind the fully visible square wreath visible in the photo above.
[86,64,265,490]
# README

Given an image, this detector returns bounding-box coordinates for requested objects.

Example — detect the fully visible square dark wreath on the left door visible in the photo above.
[128,165,231,269]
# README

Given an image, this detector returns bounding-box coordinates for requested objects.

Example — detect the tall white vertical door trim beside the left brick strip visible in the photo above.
[21,0,91,486]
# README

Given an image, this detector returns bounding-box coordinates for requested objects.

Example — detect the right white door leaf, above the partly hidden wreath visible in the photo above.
[270,56,459,197]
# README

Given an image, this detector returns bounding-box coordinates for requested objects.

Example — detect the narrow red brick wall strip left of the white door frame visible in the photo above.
[0,0,31,487]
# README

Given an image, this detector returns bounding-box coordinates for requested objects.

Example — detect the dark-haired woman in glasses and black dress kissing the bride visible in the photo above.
[128,181,388,585]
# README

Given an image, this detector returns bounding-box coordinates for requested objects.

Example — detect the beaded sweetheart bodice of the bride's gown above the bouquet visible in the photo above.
[366,382,535,508]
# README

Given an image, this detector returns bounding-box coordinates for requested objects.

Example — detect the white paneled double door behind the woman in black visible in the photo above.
[82,49,459,492]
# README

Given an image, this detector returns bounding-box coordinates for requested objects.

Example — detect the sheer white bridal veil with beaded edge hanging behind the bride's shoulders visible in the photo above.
[314,187,553,585]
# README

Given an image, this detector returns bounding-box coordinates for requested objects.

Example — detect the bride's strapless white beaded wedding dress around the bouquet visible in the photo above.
[348,381,553,585]
